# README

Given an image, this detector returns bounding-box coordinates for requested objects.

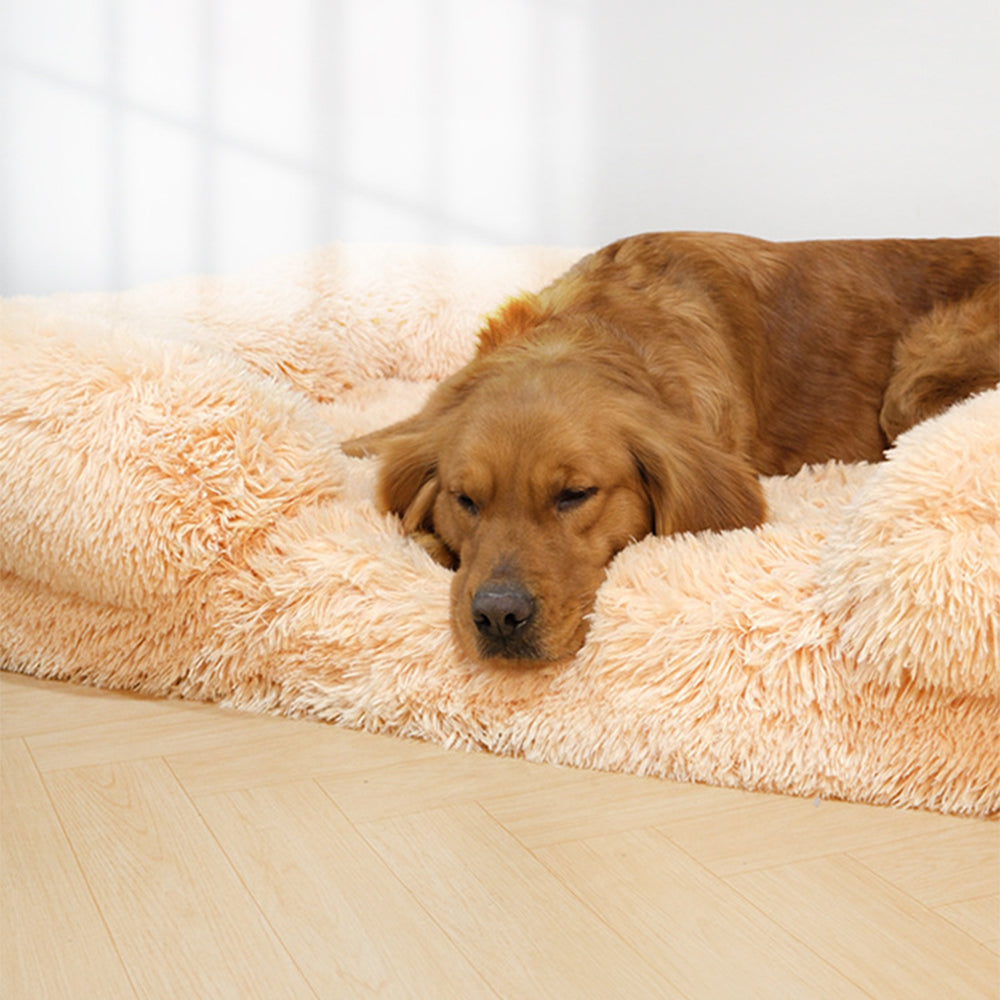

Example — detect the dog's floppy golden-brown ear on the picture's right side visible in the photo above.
[627,416,767,535]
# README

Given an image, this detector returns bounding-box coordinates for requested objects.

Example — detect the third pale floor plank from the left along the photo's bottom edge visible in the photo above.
[190,781,496,1000]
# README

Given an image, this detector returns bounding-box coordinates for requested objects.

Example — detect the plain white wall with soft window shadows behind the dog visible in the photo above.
[0,0,1000,294]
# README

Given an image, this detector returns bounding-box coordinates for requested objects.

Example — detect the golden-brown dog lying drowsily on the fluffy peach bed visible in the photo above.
[342,233,1000,666]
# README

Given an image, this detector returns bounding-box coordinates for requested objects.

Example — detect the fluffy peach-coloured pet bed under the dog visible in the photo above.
[0,247,1000,815]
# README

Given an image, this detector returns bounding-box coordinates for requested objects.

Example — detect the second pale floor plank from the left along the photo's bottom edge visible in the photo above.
[46,761,315,1000]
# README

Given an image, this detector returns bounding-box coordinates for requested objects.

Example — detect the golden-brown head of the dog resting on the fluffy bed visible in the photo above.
[344,321,764,662]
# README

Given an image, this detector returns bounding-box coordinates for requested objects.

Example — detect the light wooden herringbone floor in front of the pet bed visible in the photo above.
[0,674,1000,1000]
